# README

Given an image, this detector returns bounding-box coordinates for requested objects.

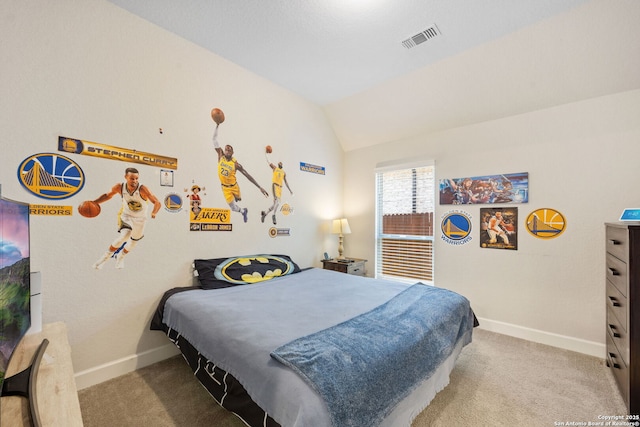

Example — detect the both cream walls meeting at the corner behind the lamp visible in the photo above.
[0,0,640,387]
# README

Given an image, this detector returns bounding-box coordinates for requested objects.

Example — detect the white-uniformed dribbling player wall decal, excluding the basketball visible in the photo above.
[93,168,162,270]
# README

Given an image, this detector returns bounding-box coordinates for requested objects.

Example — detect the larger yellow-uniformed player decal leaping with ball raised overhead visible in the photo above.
[211,108,269,222]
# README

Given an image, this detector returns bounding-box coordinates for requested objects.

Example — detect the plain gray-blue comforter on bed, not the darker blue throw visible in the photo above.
[163,269,470,427]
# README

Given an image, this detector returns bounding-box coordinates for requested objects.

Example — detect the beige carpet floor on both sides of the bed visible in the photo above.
[79,329,626,427]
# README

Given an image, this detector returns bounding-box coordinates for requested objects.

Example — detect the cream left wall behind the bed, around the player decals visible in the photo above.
[0,0,343,387]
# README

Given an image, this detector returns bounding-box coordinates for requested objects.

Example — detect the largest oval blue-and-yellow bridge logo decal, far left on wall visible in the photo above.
[18,153,84,199]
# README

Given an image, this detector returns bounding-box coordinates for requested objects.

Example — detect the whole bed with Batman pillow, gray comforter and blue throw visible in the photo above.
[151,254,477,427]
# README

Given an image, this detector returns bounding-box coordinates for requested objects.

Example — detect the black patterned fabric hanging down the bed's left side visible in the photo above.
[163,325,280,427]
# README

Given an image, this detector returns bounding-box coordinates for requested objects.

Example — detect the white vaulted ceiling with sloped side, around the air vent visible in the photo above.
[108,0,640,150]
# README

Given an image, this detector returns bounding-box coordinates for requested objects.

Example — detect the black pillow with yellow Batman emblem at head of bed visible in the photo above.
[194,254,300,289]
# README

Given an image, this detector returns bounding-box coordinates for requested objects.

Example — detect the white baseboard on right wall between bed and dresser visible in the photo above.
[478,317,606,359]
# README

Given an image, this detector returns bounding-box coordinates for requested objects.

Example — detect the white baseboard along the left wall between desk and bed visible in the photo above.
[75,343,180,390]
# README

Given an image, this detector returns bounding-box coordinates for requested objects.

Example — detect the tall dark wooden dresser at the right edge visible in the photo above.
[606,222,640,414]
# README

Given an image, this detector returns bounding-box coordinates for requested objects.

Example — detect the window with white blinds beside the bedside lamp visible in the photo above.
[376,163,435,283]
